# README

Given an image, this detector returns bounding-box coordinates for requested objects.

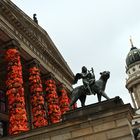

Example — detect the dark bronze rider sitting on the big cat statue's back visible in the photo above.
[81,66,95,95]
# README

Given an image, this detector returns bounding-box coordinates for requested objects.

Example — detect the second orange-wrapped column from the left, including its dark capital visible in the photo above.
[28,59,48,128]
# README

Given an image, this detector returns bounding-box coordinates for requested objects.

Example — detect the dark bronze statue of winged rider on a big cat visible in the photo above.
[70,66,110,107]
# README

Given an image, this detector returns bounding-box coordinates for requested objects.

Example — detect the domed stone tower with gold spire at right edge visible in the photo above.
[126,39,140,109]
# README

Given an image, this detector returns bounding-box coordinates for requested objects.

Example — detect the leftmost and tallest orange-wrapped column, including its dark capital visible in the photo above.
[5,40,28,135]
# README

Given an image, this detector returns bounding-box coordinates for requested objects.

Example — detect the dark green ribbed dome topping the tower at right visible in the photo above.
[126,46,140,67]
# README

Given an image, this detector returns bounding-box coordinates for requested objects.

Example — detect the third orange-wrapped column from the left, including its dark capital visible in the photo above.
[45,73,61,123]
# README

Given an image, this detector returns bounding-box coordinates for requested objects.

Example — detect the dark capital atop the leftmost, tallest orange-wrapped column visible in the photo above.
[3,39,20,50]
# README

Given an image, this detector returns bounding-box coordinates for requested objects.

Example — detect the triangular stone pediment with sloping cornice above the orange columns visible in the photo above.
[0,0,73,89]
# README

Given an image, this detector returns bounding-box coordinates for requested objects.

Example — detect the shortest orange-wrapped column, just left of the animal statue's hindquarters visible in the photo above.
[57,83,70,115]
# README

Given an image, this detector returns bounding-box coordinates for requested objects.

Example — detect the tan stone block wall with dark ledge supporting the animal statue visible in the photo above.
[2,97,134,140]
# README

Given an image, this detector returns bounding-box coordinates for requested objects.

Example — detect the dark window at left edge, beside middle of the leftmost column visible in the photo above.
[0,90,6,113]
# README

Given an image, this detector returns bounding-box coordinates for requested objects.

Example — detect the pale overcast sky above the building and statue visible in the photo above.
[12,0,140,107]
